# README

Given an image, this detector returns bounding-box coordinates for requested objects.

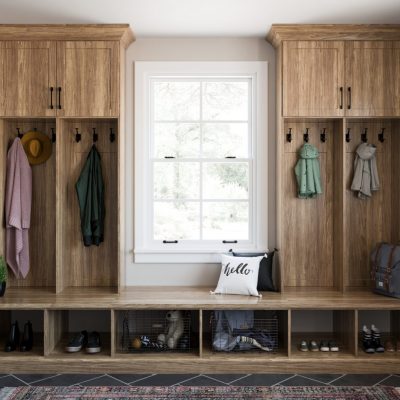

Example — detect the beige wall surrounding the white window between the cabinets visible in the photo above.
[125,38,275,286]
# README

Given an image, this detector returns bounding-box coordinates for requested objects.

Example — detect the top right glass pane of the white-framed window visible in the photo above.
[202,82,249,121]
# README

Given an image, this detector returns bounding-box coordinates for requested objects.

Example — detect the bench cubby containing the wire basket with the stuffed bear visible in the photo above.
[115,310,199,356]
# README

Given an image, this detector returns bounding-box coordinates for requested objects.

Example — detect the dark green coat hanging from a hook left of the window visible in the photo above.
[75,145,105,246]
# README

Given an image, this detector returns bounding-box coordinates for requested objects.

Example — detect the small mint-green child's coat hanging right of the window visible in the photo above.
[294,143,322,199]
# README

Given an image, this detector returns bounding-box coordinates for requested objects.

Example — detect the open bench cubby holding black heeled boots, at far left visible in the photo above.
[0,310,44,358]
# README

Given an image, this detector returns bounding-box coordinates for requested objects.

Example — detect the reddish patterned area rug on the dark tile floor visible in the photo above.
[0,386,400,400]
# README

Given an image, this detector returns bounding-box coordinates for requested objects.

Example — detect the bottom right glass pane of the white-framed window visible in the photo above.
[203,202,249,240]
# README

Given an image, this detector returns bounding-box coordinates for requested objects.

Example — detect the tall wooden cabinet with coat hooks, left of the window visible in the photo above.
[0,24,133,294]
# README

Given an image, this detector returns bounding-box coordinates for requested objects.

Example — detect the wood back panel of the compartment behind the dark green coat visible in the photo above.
[57,119,119,291]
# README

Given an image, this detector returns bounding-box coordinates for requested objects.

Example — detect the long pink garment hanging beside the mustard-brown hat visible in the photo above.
[5,138,32,278]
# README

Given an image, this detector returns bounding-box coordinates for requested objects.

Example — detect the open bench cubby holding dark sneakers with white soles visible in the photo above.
[45,310,111,359]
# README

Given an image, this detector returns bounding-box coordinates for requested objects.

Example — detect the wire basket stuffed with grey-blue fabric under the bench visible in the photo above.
[211,311,279,353]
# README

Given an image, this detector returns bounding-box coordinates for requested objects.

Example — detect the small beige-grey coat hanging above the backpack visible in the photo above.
[351,143,379,199]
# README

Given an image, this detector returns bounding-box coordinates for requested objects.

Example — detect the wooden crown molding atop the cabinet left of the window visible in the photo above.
[0,24,135,48]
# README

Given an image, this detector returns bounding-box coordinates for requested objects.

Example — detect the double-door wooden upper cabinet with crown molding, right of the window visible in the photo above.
[268,24,400,117]
